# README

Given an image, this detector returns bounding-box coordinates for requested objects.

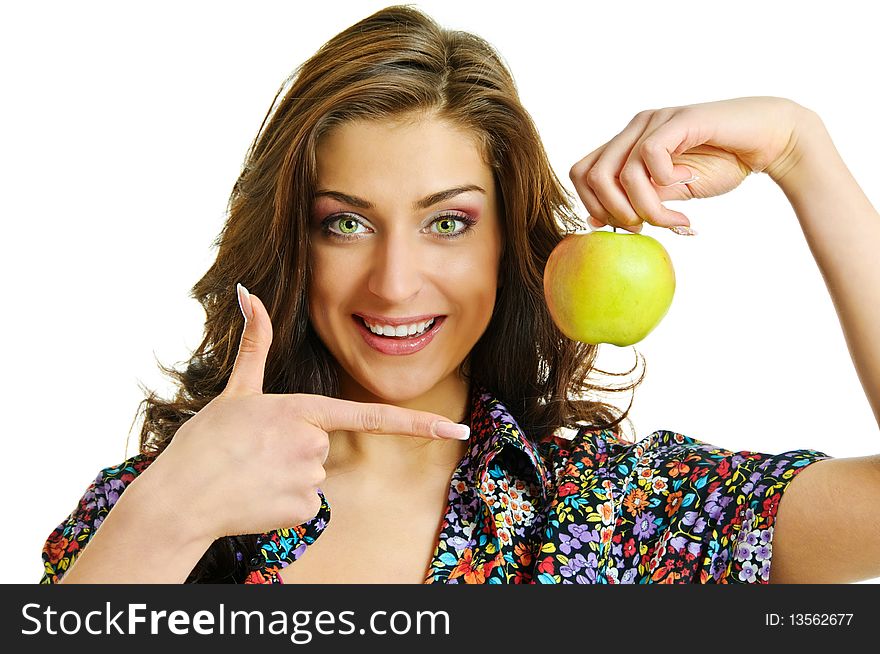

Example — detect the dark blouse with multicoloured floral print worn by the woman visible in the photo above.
[40,385,830,584]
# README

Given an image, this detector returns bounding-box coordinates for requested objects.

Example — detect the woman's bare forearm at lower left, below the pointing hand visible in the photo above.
[60,470,211,584]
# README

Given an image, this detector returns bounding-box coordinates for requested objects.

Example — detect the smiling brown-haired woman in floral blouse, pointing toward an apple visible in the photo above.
[42,7,880,583]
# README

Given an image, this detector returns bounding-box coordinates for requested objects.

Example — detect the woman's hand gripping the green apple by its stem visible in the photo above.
[569,97,809,233]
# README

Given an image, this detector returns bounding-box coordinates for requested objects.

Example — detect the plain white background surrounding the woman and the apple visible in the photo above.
[0,0,880,583]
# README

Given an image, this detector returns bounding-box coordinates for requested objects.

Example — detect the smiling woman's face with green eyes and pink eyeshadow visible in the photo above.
[309,118,502,402]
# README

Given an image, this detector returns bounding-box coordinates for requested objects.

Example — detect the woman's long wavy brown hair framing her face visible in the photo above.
[131,5,644,582]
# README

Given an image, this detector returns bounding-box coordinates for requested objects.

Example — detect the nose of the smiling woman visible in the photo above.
[369,229,427,305]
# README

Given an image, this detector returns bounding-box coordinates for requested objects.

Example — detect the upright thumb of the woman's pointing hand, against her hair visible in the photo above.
[224,284,272,395]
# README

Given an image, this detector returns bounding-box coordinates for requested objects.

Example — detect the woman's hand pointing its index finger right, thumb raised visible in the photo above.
[145,287,467,539]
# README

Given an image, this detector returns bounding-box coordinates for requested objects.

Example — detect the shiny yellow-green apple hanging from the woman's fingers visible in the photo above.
[544,231,675,347]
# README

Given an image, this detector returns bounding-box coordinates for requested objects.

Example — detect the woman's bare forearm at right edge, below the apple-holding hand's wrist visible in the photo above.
[768,111,880,425]
